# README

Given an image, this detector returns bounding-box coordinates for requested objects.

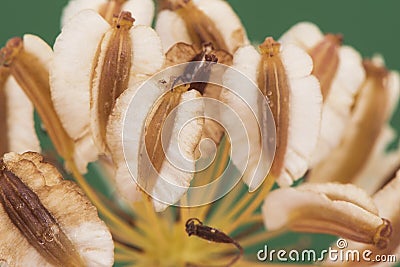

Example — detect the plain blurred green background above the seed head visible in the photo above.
[0,0,400,266]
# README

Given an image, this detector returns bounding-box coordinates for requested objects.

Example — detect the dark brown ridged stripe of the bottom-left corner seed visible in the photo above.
[0,161,84,266]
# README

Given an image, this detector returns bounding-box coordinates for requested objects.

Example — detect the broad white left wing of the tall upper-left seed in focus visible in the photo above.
[50,10,110,140]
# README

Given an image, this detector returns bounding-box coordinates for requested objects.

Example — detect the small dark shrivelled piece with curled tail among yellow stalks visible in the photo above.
[185,218,243,267]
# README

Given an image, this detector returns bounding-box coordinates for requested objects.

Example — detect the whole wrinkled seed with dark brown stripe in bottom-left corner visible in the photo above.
[0,152,114,266]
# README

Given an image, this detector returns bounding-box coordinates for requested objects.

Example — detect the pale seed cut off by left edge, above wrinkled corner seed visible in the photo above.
[0,66,40,155]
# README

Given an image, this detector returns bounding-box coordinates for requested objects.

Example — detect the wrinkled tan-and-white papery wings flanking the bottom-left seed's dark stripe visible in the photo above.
[0,153,114,266]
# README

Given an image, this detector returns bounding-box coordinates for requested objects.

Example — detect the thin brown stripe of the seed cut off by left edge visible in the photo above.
[0,66,10,156]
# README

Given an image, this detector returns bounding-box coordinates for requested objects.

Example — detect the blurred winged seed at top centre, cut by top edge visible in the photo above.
[156,0,249,53]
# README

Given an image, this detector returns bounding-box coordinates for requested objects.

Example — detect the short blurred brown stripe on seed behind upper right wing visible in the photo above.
[309,34,342,101]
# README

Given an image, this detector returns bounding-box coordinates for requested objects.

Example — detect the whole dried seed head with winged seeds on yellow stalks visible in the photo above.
[0,0,400,267]
